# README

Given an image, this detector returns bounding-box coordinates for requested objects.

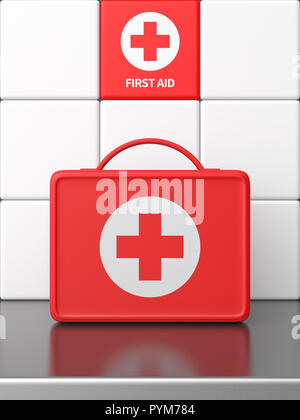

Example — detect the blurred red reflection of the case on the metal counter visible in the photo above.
[50,324,250,377]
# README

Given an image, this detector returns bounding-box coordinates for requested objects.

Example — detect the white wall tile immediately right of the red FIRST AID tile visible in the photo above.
[201,0,300,99]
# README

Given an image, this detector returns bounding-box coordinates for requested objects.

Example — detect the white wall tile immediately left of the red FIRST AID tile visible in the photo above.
[1,0,99,99]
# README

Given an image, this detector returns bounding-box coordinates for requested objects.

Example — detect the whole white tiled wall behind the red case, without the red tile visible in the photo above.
[0,0,300,299]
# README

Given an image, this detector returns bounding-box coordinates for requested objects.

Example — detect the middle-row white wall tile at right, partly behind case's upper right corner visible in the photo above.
[201,101,300,200]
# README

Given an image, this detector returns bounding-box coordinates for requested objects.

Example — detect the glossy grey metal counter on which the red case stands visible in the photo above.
[0,302,300,398]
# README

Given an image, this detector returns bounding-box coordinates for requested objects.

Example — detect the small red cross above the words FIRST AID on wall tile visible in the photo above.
[131,22,170,61]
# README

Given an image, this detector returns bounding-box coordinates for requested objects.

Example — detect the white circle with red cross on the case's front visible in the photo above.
[100,197,200,298]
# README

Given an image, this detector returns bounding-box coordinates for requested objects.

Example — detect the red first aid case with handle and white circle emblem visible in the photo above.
[50,139,250,322]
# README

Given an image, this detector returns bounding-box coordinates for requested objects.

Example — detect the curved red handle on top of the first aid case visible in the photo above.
[97,139,203,170]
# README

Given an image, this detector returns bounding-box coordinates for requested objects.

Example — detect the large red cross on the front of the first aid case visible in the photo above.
[117,214,183,280]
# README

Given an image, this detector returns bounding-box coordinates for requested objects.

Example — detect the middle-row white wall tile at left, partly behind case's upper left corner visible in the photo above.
[1,101,100,199]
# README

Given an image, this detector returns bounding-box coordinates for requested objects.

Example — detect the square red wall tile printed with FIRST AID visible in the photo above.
[100,0,200,99]
